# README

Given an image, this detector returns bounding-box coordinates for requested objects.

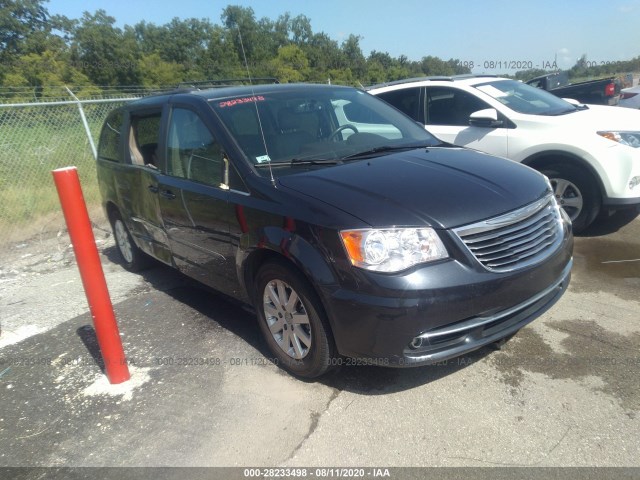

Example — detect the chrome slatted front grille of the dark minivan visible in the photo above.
[454,195,564,272]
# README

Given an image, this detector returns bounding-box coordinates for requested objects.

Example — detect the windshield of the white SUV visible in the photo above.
[476,80,578,115]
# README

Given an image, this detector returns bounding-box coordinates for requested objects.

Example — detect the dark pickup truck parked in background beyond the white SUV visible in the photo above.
[527,72,620,105]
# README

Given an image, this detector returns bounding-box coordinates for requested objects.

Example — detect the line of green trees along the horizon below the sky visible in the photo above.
[0,0,640,99]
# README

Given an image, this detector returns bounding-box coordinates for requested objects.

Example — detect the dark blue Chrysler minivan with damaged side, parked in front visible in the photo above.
[98,85,573,377]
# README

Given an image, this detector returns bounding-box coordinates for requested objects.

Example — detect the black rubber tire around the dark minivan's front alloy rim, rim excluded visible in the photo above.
[254,261,335,378]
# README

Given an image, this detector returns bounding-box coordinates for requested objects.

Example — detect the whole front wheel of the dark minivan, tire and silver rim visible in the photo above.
[254,261,336,378]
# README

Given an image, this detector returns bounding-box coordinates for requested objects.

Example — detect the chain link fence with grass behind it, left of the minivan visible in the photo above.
[0,92,135,245]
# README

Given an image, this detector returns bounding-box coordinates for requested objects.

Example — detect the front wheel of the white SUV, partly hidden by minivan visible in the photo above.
[542,165,602,233]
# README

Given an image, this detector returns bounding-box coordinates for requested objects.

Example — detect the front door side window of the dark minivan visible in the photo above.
[167,108,224,187]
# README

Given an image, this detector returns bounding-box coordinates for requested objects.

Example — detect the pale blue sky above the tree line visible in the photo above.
[45,0,640,73]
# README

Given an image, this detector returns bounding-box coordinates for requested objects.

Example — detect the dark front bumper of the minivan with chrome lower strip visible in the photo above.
[324,240,573,367]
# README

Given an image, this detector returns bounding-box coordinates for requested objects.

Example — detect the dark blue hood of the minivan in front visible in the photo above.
[278,147,548,228]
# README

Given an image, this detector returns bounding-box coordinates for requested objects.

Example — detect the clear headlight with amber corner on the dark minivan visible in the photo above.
[340,228,449,272]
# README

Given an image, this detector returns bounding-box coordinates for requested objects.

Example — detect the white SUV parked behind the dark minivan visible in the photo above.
[368,75,640,232]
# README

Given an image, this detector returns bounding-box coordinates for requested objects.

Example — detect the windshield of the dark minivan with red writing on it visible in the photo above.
[210,86,441,170]
